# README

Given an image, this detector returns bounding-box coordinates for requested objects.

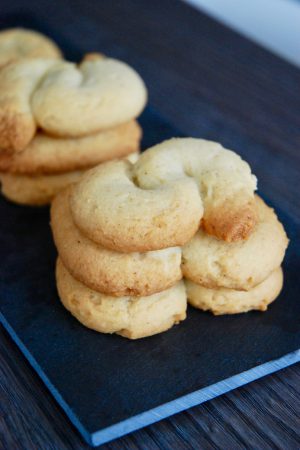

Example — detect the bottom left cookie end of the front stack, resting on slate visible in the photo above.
[56,258,187,339]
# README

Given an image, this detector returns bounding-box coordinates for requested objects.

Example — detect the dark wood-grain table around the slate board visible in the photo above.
[0,0,300,450]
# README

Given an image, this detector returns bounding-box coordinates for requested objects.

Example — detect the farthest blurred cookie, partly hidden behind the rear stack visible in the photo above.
[0,28,62,67]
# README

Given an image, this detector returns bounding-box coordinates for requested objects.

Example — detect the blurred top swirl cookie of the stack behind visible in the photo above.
[0,58,147,151]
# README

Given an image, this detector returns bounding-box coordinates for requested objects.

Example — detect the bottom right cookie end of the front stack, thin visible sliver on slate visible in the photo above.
[185,267,283,315]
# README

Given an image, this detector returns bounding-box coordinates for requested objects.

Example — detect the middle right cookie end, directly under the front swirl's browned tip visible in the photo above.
[182,196,288,290]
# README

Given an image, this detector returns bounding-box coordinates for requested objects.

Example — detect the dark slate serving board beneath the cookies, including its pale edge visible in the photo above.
[0,15,300,445]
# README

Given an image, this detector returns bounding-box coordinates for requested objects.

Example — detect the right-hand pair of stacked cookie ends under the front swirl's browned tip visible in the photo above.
[182,196,288,315]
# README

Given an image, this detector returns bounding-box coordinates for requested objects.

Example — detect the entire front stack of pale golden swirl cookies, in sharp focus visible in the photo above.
[51,139,288,338]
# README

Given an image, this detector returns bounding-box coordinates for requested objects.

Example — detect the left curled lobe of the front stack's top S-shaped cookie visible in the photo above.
[70,161,202,253]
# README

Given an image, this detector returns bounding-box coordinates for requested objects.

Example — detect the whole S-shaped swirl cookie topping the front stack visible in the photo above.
[70,138,256,252]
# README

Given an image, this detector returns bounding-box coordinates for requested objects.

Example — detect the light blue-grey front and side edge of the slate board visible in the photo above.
[0,313,300,447]
